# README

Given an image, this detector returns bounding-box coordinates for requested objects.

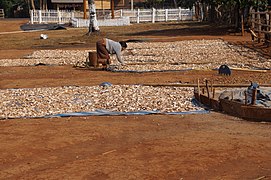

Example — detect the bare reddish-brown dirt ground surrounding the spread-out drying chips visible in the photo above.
[0,19,271,180]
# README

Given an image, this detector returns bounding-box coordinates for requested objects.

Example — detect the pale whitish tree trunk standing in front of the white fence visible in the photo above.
[87,0,100,35]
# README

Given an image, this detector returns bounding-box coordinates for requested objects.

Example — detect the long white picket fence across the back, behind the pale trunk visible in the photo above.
[30,8,195,24]
